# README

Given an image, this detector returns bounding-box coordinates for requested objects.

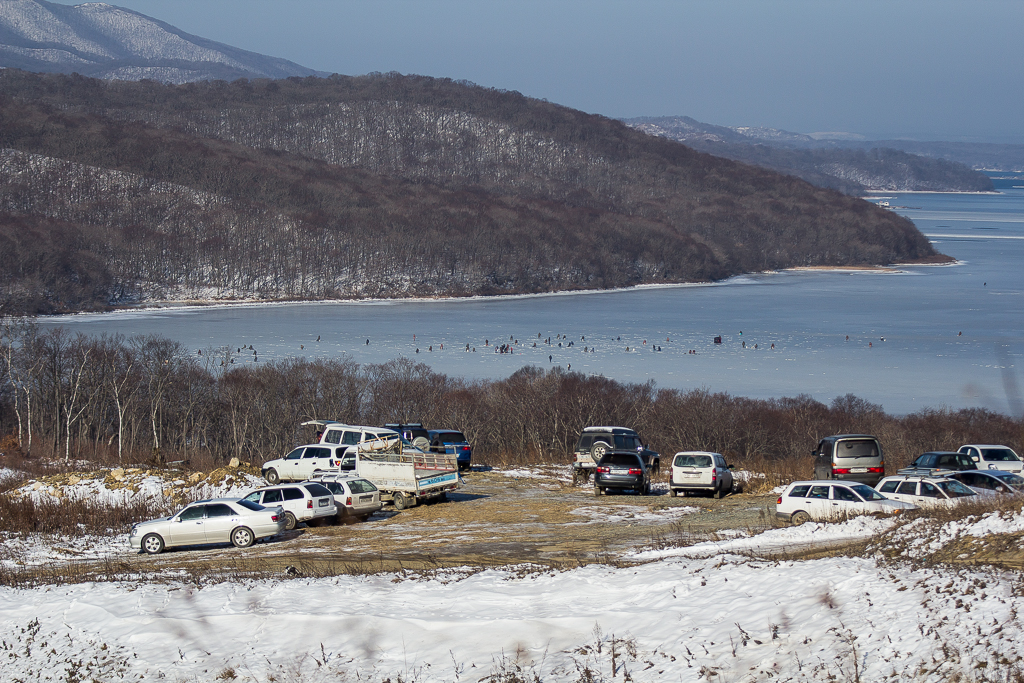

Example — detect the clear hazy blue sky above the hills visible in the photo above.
[51,0,1024,142]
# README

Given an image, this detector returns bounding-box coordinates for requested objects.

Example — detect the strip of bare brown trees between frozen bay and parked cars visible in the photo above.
[0,318,1024,476]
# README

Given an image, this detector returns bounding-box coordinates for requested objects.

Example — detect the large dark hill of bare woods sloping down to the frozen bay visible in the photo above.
[0,70,944,311]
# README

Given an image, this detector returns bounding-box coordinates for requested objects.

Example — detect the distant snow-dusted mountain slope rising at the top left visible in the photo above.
[0,0,316,83]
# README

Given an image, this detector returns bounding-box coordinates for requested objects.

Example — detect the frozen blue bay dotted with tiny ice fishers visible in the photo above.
[42,178,1024,415]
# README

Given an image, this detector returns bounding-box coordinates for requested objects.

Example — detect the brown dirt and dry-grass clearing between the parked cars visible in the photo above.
[112,466,775,575]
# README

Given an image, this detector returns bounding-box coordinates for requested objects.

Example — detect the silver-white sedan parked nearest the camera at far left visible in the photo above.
[128,498,285,555]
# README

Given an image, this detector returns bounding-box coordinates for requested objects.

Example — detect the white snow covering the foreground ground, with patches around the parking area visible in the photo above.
[0,471,1024,683]
